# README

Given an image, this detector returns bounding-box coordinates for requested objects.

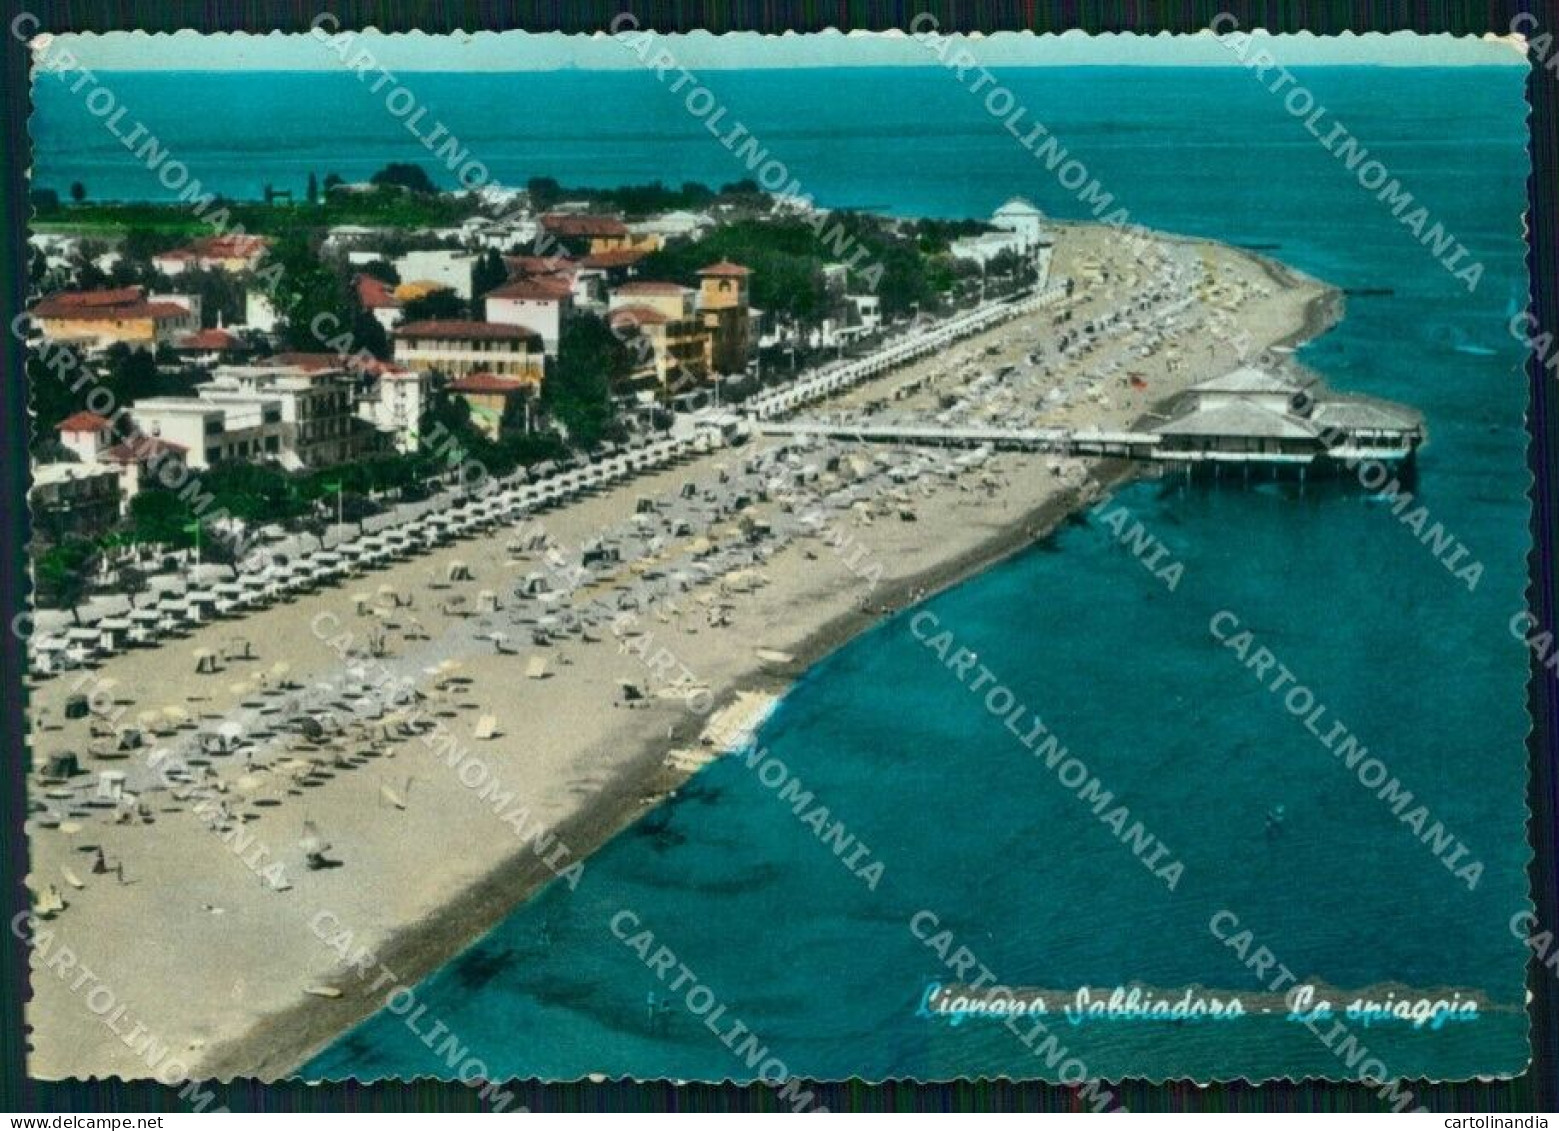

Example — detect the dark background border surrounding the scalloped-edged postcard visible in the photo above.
[0,0,1559,1112]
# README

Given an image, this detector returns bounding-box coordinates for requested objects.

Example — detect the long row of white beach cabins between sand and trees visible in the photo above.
[30,287,1060,679]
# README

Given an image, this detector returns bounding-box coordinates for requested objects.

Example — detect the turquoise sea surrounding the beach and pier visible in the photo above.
[33,67,1528,1080]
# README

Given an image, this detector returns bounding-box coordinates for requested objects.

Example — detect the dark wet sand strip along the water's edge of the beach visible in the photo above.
[203,248,1342,1083]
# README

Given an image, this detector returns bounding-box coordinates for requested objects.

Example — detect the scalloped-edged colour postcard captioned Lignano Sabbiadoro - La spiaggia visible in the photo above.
[11,14,1553,1111]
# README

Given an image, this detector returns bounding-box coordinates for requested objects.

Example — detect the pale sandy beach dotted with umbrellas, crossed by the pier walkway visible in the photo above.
[28,226,1341,1080]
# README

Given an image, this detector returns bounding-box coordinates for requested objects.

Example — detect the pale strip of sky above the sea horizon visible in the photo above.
[34,31,1526,73]
